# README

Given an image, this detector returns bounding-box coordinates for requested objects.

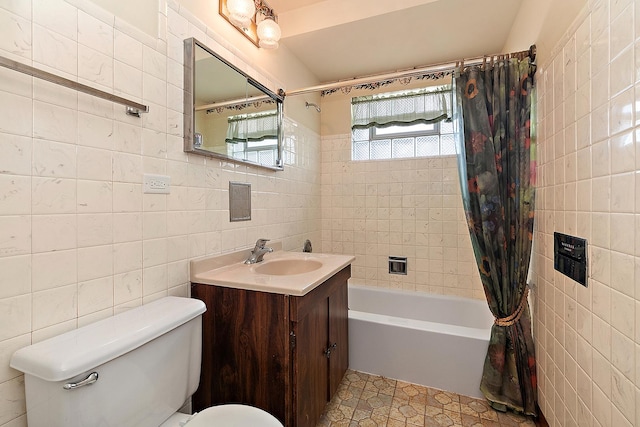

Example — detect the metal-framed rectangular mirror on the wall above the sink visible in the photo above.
[184,38,284,170]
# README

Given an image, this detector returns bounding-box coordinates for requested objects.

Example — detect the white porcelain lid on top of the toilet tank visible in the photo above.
[10,297,206,381]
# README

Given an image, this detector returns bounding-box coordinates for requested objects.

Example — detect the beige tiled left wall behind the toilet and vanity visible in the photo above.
[0,0,321,427]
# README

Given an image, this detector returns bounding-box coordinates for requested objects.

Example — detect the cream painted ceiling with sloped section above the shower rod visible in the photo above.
[267,0,528,83]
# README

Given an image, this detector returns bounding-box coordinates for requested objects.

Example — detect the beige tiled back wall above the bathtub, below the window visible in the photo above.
[321,135,484,298]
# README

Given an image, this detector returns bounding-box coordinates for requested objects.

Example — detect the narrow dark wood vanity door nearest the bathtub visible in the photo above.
[329,282,349,396]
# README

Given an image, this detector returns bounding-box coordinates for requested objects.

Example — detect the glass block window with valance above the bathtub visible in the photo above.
[351,87,455,160]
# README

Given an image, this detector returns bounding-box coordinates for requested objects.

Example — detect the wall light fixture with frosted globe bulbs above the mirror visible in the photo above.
[219,0,282,49]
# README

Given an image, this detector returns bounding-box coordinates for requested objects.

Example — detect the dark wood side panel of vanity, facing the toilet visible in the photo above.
[191,284,291,425]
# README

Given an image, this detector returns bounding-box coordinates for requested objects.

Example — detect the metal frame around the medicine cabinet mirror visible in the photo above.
[183,37,284,171]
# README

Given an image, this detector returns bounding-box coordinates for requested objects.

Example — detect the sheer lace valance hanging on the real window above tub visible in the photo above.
[351,89,451,130]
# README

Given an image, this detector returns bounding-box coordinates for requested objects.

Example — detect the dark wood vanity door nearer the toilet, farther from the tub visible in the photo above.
[293,299,329,427]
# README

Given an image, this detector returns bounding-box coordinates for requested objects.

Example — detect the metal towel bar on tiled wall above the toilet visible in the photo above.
[0,56,149,117]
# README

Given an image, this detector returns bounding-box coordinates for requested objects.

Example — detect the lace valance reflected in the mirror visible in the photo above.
[225,111,278,144]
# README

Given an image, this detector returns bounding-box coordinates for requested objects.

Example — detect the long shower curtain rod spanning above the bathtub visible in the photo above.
[286,45,536,96]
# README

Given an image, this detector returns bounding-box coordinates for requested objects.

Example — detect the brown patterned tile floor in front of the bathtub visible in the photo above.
[317,370,536,427]
